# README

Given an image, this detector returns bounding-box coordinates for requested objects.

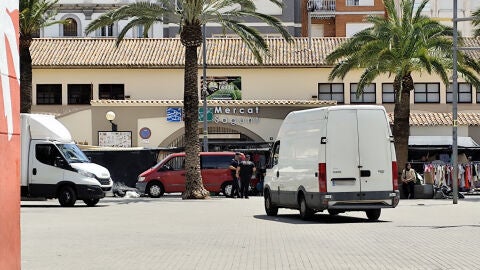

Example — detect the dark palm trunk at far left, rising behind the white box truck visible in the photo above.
[20,38,32,113]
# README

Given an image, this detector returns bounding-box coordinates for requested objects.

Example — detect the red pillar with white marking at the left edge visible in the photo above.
[0,0,20,270]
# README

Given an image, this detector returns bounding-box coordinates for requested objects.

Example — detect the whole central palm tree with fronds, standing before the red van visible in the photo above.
[86,0,291,199]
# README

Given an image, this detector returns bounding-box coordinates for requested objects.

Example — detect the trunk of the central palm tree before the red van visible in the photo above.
[182,26,209,199]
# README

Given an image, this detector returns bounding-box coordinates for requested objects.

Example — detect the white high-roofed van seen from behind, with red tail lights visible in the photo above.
[264,105,400,220]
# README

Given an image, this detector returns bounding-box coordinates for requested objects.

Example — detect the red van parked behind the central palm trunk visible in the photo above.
[136,152,246,198]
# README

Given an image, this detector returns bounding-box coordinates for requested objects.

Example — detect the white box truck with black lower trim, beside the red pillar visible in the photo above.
[20,114,113,207]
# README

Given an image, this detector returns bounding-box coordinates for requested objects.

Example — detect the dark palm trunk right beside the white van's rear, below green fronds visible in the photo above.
[393,74,413,183]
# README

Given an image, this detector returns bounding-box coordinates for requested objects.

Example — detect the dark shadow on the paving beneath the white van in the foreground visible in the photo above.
[253,214,391,224]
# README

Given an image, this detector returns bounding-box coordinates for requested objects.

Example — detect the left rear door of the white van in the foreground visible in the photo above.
[325,109,360,194]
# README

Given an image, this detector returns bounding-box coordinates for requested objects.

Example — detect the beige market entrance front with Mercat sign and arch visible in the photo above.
[80,100,336,151]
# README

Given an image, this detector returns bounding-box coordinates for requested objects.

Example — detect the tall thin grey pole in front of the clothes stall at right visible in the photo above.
[452,0,458,204]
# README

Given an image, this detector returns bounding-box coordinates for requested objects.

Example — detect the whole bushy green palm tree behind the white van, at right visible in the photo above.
[327,0,480,181]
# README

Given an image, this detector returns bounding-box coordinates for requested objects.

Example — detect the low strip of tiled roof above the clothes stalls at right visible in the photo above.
[388,112,480,126]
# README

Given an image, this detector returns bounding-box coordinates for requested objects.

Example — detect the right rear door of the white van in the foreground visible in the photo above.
[357,109,393,194]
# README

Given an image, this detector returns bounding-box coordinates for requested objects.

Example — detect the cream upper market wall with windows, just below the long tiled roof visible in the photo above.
[33,68,478,107]
